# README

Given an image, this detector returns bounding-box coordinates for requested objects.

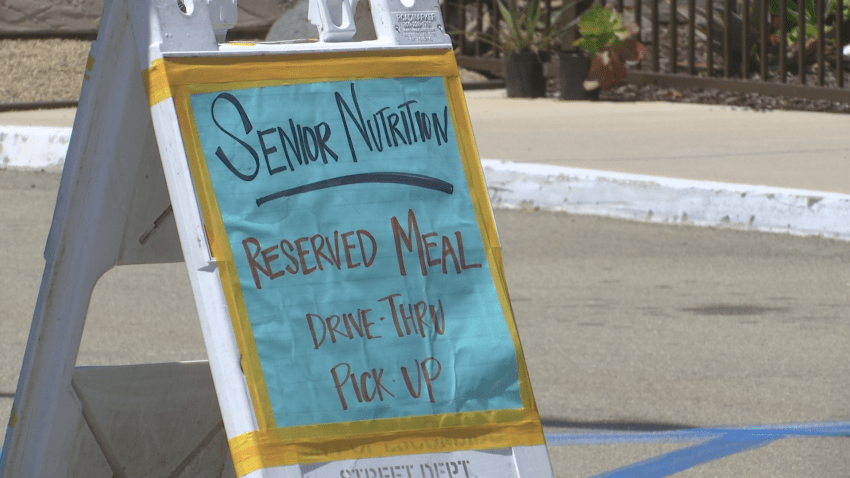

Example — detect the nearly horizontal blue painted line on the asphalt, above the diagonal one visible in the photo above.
[546,421,850,446]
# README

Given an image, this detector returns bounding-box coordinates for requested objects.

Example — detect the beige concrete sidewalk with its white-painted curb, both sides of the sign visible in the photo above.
[0,90,850,239]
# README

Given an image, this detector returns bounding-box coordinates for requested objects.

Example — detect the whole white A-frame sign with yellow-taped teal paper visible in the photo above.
[0,0,552,478]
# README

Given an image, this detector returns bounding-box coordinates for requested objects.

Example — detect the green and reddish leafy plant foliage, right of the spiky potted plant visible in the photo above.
[573,5,646,90]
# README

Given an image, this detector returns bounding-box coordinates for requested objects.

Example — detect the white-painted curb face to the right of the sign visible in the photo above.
[481,159,850,240]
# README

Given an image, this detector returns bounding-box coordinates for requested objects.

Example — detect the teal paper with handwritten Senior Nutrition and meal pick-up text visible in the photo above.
[191,77,522,427]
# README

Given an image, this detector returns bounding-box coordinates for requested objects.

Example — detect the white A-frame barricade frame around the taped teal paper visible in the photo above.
[0,0,552,478]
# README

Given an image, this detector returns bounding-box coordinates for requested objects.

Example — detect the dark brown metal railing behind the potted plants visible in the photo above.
[446,0,850,102]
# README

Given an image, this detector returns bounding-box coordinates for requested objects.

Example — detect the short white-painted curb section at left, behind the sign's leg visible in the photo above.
[0,126,71,169]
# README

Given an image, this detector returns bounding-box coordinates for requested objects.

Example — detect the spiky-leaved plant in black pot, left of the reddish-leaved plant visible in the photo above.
[485,0,572,98]
